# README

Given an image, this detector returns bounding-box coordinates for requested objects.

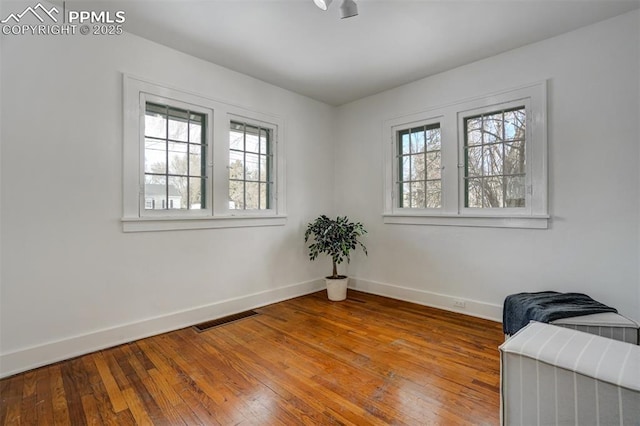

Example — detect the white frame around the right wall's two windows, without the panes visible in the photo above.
[383,81,549,229]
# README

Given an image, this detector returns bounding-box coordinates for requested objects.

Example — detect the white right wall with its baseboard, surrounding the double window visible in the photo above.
[335,11,640,320]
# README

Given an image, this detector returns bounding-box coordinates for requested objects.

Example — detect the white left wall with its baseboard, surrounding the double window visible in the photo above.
[0,11,335,375]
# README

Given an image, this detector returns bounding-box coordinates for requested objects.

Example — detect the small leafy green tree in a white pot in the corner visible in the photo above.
[304,215,367,301]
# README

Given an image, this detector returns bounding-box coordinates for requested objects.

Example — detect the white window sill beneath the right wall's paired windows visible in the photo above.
[383,214,550,229]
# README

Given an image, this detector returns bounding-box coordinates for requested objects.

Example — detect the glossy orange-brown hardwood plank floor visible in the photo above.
[0,290,503,426]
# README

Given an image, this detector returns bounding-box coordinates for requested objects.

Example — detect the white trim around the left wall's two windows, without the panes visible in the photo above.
[121,74,287,232]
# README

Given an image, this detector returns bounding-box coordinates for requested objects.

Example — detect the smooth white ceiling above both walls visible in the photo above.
[76,0,640,105]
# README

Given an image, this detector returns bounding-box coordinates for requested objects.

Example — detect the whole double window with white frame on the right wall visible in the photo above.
[384,82,548,228]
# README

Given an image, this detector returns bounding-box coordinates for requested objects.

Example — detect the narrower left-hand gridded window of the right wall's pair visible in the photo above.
[398,123,442,209]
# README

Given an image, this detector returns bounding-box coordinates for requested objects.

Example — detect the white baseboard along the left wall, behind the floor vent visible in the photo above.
[0,279,325,378]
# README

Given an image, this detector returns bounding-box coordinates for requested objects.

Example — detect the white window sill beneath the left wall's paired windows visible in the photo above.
[121,216,287,232]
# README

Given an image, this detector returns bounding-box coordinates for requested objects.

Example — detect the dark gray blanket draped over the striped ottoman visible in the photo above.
[502,291,618,335]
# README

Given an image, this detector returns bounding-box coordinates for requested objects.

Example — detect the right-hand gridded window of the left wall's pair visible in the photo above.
[229,121,273,210]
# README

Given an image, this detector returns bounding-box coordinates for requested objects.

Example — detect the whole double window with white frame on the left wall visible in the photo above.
[122,76,286,232]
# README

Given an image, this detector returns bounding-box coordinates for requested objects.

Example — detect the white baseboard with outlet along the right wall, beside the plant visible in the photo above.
[349,278,502,322]
